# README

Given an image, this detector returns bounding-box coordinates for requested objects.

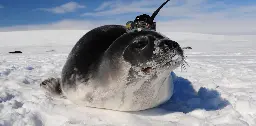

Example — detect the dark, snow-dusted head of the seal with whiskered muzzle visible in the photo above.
[119,31,184,80]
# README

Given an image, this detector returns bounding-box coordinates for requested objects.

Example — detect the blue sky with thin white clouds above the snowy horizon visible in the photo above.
[0,0,256,33]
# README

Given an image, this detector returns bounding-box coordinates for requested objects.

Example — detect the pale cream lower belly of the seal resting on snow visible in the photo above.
[63,71,173,111]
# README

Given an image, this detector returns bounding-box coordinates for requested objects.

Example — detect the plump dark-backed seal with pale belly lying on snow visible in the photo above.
[40,25,184,111]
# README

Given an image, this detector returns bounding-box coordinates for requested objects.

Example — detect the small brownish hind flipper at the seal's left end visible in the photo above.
[40,78,62,95]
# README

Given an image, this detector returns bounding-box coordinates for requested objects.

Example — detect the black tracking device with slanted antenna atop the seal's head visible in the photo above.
[126,0,170,31]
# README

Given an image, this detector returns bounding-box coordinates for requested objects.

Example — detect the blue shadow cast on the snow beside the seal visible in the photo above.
[134,72,230,115]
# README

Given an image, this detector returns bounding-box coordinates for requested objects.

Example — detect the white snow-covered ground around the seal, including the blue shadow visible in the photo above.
[0,30,256,126]
